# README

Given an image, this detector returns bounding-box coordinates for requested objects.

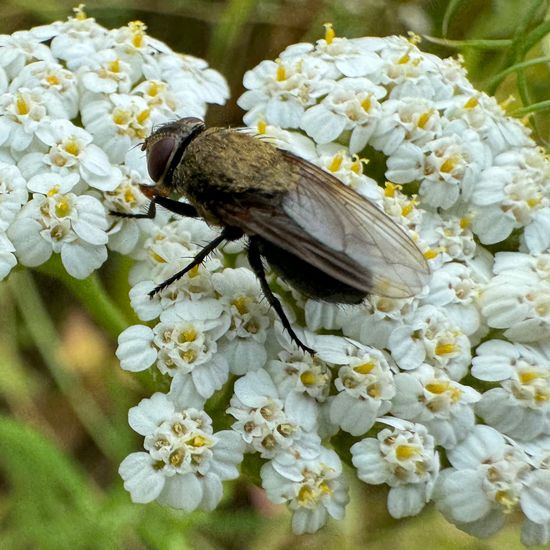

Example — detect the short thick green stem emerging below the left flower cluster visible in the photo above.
[38,254,131,339]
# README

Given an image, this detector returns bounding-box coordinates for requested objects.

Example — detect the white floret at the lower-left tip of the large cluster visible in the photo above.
[119,393,243,512]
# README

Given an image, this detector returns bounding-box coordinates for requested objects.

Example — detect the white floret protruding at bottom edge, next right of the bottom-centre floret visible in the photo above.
[351,424,439,518]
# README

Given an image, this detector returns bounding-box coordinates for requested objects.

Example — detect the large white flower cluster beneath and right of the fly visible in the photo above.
[117,26,550,544]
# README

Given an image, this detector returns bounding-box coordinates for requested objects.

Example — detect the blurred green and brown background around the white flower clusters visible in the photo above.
[0,0,550,550]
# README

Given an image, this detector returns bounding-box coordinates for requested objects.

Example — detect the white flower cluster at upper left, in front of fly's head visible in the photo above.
[0,7,228,279]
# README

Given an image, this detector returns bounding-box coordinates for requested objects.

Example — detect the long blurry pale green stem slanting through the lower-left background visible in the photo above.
[8,270,123,461]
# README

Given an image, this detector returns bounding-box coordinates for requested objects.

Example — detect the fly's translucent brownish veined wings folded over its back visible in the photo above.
[216,151,430,298]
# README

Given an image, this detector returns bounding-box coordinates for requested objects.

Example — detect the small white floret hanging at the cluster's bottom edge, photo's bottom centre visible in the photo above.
[260,447,349,535]
